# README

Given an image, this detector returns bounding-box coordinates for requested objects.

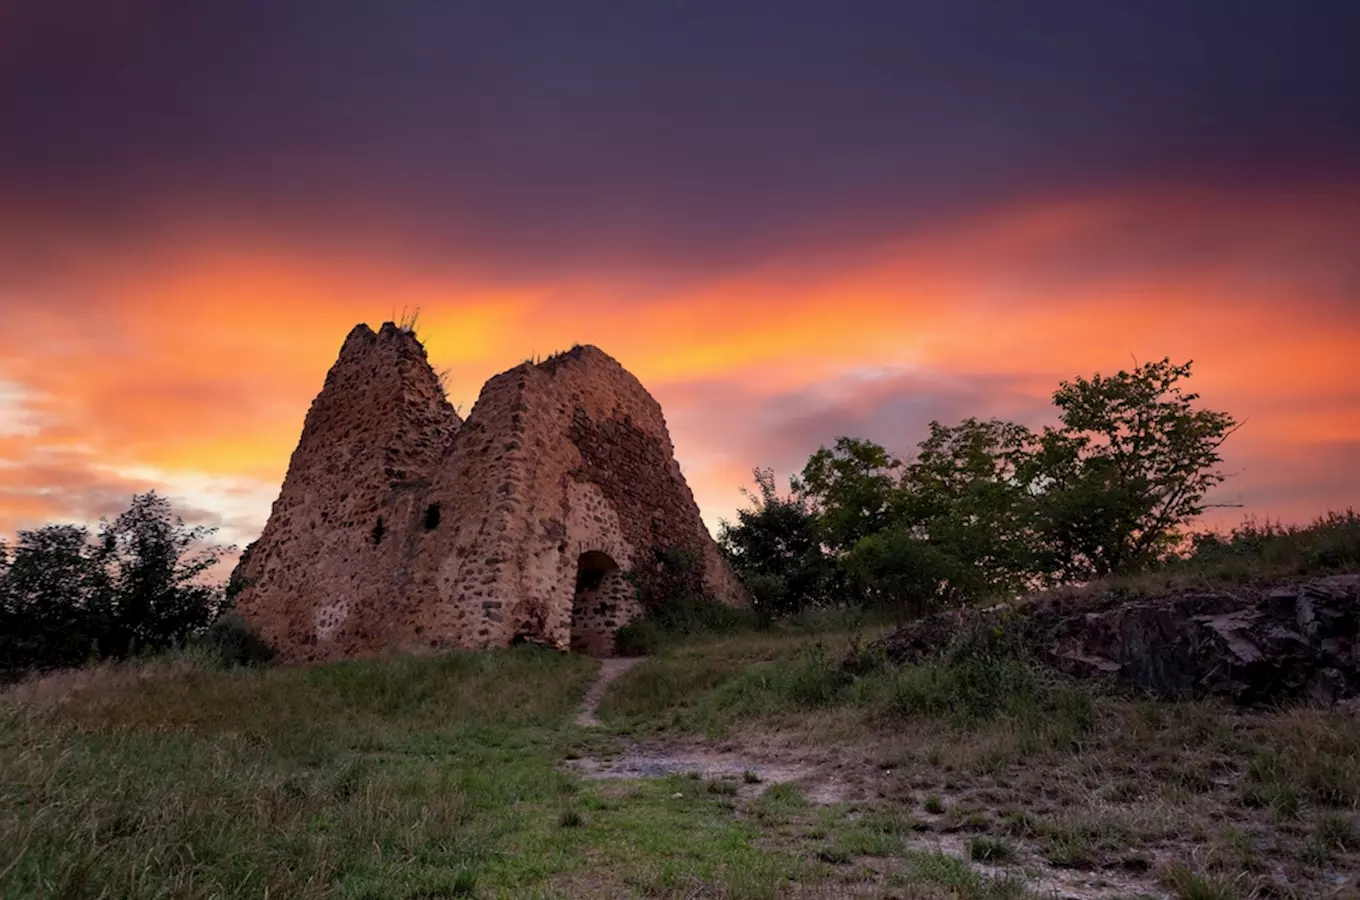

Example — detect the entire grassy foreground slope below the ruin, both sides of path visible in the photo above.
[0,623,1360,900]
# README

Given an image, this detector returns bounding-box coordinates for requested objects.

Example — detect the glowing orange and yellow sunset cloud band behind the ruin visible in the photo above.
[0,188,1360,540]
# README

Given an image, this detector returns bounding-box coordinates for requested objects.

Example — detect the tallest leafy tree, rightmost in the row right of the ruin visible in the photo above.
[1025,359,1238,579]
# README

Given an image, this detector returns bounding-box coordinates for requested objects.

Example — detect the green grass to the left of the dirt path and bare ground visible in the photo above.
[0,648,811,899]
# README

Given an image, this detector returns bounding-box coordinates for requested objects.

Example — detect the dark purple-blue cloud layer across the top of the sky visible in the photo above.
[0,0,1360,271]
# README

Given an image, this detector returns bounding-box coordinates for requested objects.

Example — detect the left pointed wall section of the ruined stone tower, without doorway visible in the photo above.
[237,324,461,659]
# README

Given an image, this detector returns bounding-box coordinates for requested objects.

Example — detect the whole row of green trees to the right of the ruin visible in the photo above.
[721,359,1238,616]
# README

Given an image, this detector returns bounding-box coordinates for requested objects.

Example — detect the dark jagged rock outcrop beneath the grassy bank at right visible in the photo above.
[876,575,1360,706]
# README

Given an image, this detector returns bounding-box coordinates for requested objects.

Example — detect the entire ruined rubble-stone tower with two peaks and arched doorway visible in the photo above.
[234,322,745,662]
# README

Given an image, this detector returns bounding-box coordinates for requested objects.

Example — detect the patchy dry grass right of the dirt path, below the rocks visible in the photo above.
[601,619,1360,897]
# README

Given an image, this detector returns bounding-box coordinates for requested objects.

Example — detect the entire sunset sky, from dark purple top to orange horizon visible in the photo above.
[0,0,1360,554]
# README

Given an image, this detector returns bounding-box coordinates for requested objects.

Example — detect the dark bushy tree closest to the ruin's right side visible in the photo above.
[718,469,838,616]
